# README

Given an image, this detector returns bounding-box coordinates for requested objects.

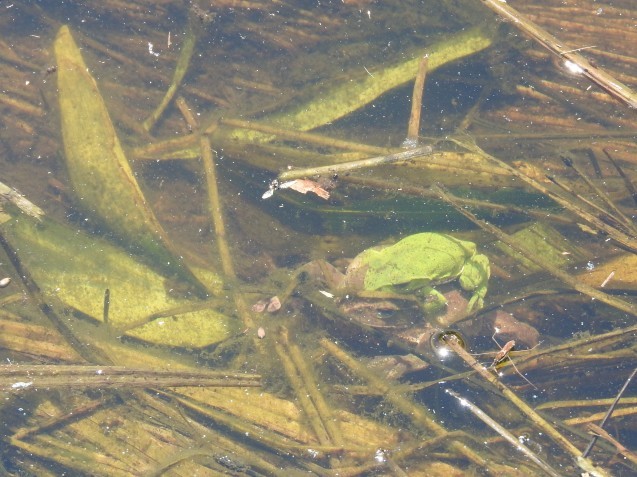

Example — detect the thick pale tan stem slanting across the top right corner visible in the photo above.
[482,0,637,108]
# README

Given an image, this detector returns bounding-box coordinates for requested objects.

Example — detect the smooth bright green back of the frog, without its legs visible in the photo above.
[365,233,476,290]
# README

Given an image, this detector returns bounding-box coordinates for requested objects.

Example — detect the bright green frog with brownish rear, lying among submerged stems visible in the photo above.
[303,232,490,314]
